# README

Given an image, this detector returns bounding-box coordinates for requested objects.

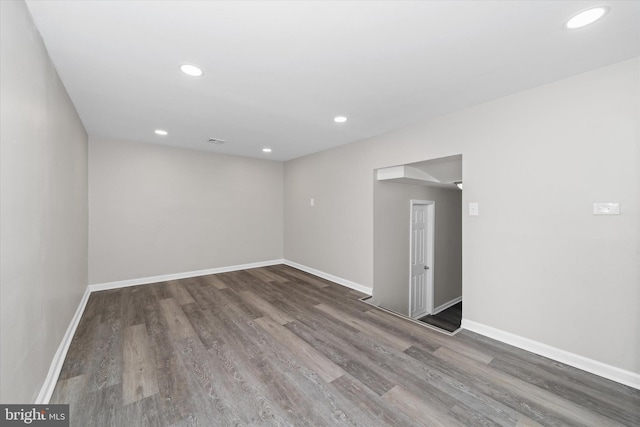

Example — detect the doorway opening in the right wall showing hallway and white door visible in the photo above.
[367,155,462,334]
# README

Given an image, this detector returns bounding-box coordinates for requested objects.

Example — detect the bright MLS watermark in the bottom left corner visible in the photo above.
[0,405,69,427]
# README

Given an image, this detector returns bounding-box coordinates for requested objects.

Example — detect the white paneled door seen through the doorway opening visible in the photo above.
[409,201,433,319]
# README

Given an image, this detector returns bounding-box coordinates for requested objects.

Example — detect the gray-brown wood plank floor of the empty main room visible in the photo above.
[51,265,640,427]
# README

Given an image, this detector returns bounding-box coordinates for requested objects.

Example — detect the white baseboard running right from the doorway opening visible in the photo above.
[462,319,640,390]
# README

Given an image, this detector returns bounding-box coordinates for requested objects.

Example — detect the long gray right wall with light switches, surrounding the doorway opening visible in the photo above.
[285,59,640,372]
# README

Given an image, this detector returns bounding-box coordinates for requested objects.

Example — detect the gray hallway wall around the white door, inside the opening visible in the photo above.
[371,181,462,316]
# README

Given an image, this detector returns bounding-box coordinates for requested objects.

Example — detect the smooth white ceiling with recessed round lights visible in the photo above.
[27,0,640,160]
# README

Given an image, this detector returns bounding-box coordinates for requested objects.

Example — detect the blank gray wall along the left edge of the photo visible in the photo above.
[0,1,87,403]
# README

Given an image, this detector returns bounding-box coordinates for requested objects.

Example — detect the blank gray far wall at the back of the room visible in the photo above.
[89,138,283,284]
